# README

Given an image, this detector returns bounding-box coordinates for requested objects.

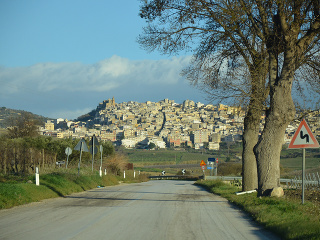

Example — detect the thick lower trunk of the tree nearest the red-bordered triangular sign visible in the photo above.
[254,79,295,196]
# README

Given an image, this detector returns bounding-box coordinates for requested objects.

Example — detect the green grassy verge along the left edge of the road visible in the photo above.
[0,169,147,209]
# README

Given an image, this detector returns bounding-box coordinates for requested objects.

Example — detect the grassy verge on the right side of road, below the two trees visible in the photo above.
[196,180,320,239]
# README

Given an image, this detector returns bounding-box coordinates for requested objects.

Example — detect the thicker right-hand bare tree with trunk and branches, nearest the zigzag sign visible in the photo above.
[248,0,320,195]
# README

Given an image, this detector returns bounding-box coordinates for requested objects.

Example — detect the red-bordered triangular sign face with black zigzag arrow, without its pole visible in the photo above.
[288,119,319,148]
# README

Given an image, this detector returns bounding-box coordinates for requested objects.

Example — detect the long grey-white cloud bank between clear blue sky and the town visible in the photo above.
[0,55,205,119]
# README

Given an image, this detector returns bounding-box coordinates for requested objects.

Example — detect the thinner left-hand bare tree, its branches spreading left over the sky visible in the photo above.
[139,0,268,190]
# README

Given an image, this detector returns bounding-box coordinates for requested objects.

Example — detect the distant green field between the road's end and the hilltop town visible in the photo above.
[123,143,320,176]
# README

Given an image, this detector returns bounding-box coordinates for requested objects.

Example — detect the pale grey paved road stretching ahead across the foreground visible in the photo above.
[0,180,277,240]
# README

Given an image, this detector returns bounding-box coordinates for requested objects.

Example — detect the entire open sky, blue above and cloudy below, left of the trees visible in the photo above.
[0,0,208,119]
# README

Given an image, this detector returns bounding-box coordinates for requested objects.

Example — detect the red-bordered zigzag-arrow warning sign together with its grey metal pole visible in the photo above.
[288,119,319,204]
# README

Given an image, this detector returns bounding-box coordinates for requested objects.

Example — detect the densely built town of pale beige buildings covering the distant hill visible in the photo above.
[41,98,320,150]
